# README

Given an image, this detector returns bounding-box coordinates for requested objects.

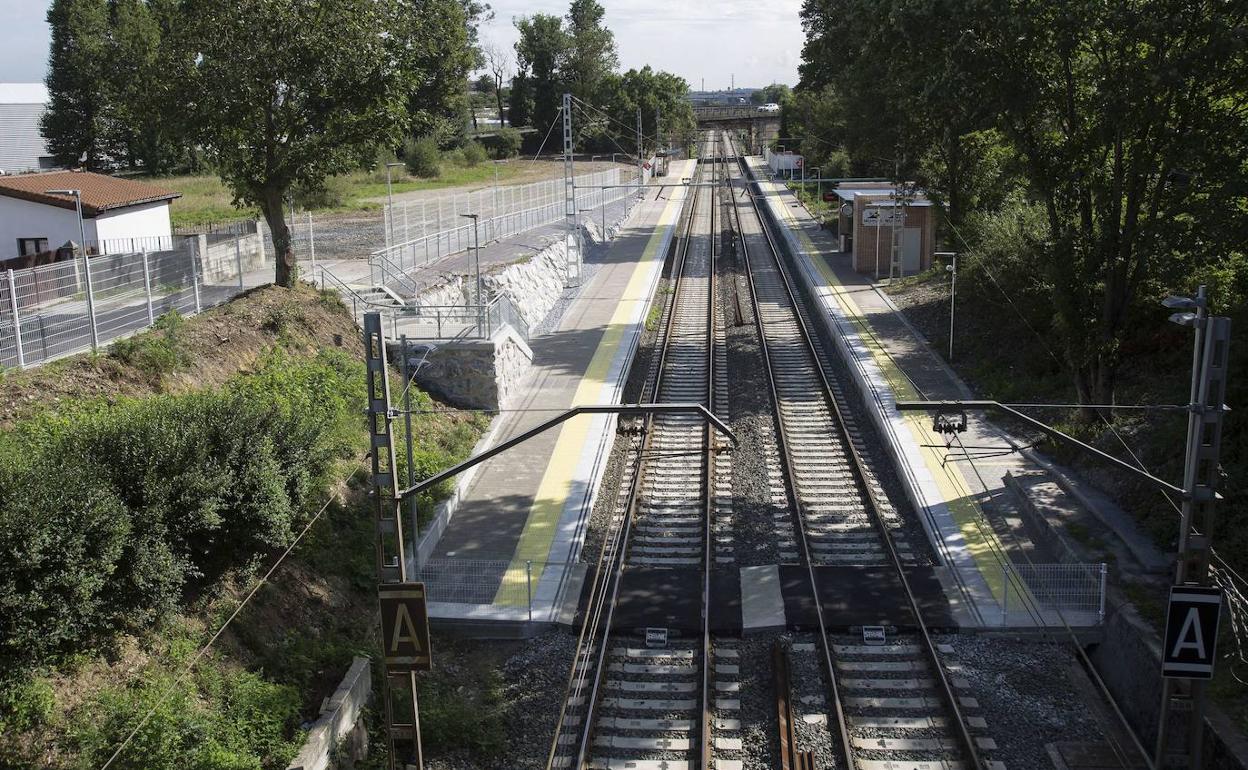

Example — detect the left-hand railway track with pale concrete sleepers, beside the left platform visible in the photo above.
[547,137,731,770]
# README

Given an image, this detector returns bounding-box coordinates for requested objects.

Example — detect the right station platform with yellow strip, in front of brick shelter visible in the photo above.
[746,156,1103,626]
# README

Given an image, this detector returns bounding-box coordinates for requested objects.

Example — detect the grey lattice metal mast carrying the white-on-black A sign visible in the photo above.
[1153,286,1231,770]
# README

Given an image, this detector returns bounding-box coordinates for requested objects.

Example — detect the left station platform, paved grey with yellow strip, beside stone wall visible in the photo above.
[414,161,694,623]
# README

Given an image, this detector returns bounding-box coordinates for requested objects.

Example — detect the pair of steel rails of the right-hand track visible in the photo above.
[736,135,982,768]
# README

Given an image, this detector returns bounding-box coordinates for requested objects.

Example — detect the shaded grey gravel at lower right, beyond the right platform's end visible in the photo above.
[935,634,1104,769]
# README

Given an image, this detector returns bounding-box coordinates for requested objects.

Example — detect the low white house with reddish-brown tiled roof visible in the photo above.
[0,171,181,267]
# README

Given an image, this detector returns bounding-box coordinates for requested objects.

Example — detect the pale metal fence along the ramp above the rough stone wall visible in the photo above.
[369,168,624,283]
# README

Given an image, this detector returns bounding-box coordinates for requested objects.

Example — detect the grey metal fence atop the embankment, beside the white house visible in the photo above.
[0,230,257,368]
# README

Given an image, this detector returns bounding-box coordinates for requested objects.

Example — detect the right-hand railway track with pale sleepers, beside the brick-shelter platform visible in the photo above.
[726,132,1002,770]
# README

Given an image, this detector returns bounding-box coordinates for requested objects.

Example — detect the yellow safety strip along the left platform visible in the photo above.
[494,170,684,607]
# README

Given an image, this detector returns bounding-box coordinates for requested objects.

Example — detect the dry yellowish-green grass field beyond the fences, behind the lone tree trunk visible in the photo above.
[162,162,524,227]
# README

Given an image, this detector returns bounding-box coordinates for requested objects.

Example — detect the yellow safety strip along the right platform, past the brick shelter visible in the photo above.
[748,168,1017,602]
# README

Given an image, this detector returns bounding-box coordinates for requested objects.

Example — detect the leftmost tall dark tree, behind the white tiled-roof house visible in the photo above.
[40,0,109,170]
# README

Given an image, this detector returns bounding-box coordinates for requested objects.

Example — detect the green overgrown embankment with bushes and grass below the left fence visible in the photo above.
[0,287,484,770]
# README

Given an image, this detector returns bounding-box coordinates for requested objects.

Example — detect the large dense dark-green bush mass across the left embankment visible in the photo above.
[0,353,364,670]
